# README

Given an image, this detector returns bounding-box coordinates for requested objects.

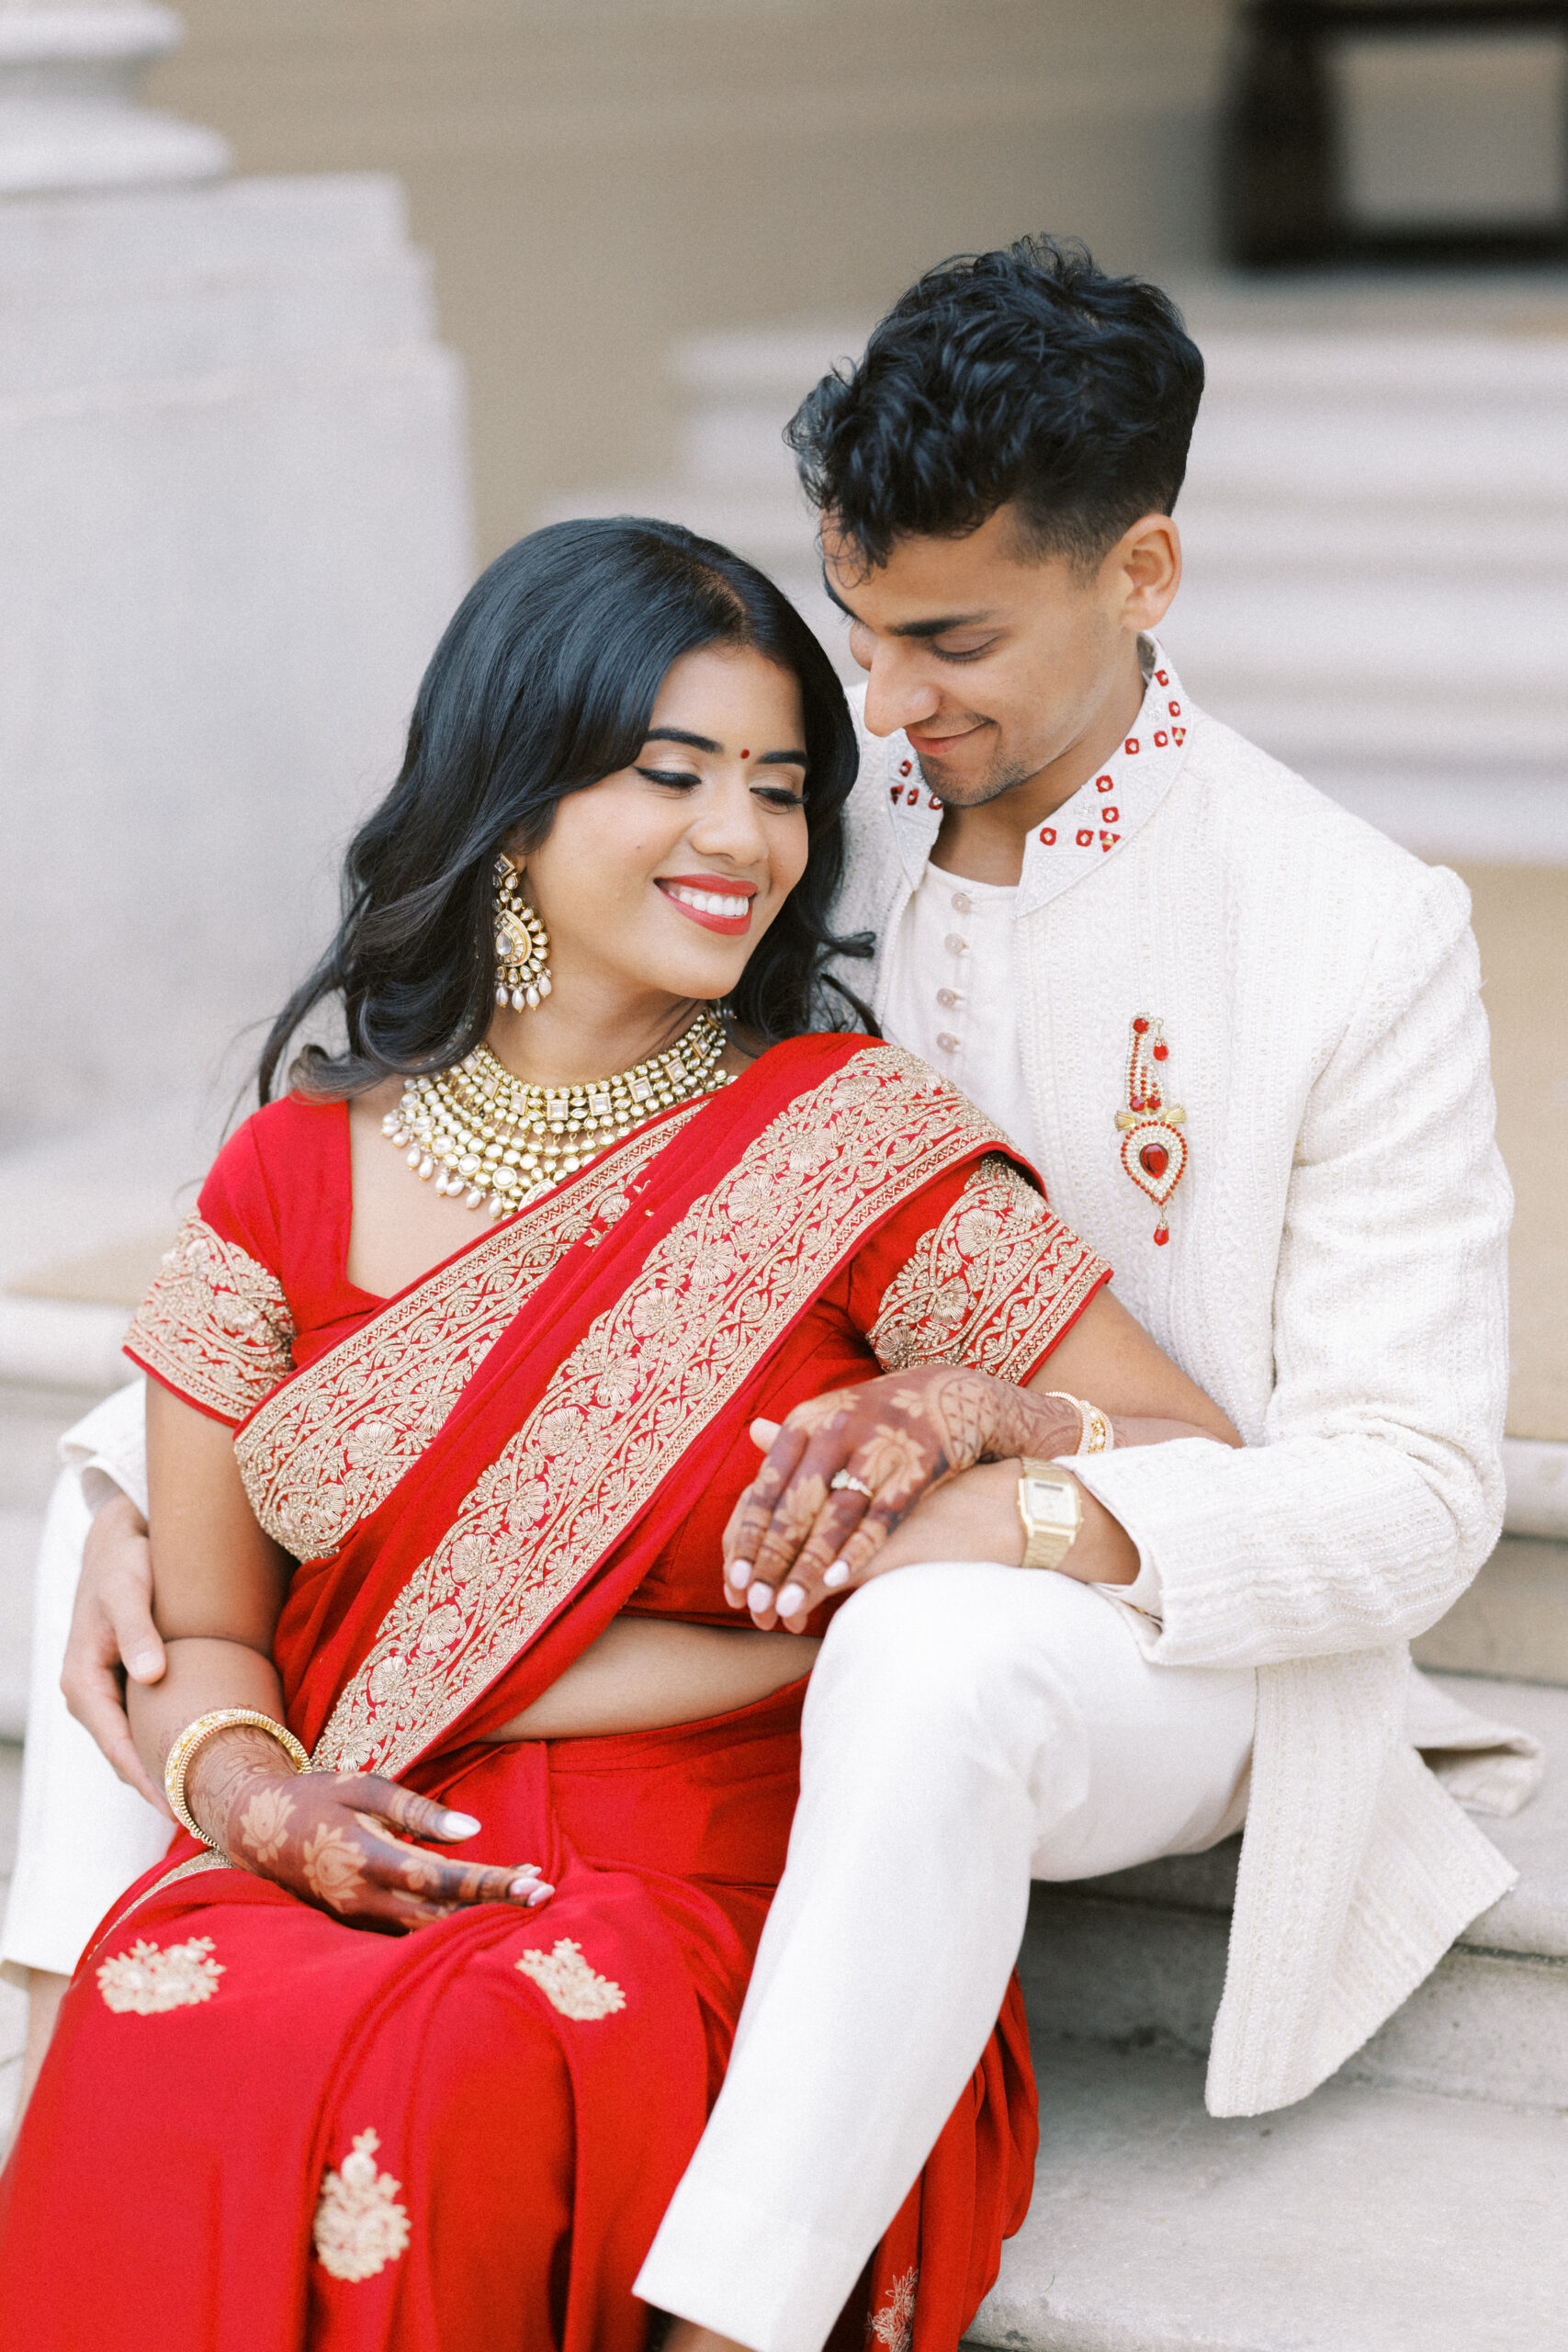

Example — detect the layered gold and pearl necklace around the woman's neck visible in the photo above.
[381,1007,728,1216]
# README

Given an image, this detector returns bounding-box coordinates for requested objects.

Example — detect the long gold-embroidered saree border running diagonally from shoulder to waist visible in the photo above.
[312,1046,1006,1773]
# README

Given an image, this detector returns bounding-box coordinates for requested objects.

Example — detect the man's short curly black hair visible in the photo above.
[785,238,1203,570]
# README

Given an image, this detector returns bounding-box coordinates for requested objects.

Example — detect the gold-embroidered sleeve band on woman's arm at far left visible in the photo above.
[125,1209,294,1420]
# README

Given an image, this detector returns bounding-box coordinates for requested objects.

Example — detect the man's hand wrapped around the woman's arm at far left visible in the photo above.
[59,1491,174,1820]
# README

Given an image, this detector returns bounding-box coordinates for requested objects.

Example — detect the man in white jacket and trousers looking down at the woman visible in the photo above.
[12,243,1509,2352]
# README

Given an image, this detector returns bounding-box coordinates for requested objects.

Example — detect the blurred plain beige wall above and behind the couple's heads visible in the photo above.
[148,0,1229,555]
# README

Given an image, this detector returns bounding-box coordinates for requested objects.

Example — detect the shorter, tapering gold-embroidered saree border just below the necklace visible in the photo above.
[235,1103,703,1559]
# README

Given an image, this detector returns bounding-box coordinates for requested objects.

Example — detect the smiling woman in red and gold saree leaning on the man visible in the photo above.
[0,522,1224,2352]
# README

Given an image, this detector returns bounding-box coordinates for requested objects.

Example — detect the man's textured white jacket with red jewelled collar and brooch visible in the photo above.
[860,649,1512,2114]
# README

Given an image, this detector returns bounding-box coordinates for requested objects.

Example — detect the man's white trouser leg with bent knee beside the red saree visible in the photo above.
[637,1564,1256,2352]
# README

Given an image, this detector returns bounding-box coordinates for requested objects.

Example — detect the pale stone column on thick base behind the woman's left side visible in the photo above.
[0,0,470,1152]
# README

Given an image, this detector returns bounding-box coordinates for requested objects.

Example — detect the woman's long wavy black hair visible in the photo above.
[256,515,872,1103]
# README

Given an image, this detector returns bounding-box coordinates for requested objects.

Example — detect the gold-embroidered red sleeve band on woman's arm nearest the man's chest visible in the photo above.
[872,1155,1110,1381]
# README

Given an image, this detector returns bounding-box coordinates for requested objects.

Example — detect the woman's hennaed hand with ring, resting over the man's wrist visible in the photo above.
[724,1364,1081,1633]
